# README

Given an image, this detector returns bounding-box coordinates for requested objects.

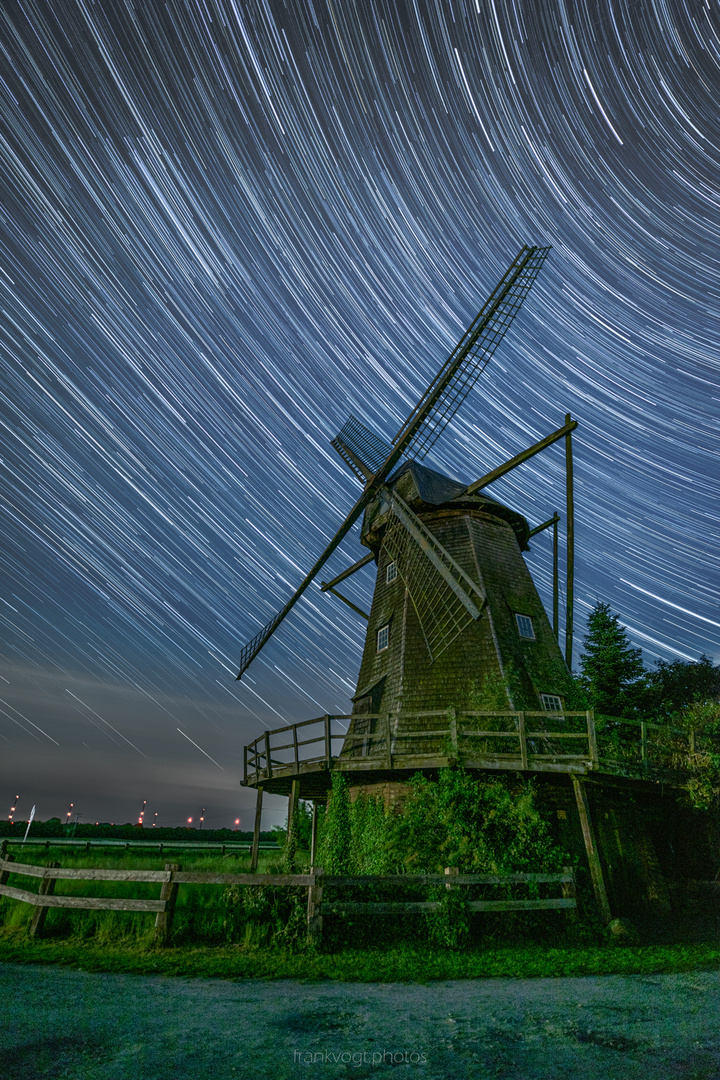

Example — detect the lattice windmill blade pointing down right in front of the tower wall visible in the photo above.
[383,494,487,660]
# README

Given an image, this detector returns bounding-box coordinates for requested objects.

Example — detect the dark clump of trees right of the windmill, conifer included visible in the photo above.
[578,603,720,728]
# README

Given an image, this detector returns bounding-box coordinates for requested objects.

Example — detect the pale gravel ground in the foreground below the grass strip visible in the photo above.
[0,964,720,1080]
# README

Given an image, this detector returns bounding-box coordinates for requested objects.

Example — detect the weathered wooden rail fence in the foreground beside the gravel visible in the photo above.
[0,855,578,941]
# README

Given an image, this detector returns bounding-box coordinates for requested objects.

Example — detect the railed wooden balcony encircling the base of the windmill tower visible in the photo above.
[243,711,717,798]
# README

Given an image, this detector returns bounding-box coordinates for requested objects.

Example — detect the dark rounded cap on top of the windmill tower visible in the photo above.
[363,461,530,551]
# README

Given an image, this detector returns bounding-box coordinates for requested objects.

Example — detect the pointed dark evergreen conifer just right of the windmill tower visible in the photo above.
[580,602,646,716]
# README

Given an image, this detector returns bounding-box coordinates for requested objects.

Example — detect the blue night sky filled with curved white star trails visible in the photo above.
[0,0,720,828]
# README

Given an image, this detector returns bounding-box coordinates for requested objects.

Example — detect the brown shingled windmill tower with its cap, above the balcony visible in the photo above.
[343,462,571,755]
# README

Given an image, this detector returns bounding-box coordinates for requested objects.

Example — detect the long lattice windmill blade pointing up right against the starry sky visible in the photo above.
[393,247,551,460]
